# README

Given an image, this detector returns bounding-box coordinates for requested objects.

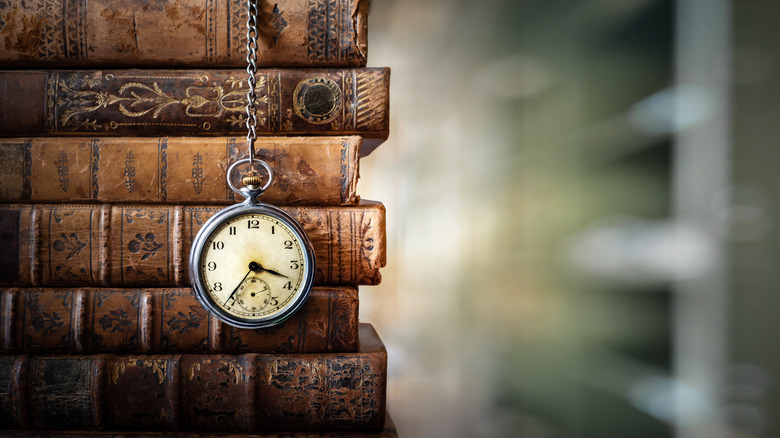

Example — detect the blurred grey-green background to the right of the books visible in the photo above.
[358,0,780,438]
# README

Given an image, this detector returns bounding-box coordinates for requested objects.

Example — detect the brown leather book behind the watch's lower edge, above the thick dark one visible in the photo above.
[0,286,358,354]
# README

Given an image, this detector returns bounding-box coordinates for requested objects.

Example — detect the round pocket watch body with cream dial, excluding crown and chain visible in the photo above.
[192,210,313,327]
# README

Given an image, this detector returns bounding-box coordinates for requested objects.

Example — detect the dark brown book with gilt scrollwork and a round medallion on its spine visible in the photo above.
[0,68,390,142]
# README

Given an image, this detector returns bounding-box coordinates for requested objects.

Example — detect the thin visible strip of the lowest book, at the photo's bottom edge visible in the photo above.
[2,415,398,438]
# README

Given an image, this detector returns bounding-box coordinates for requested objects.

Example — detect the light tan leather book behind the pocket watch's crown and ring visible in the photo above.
[0,136,361,205]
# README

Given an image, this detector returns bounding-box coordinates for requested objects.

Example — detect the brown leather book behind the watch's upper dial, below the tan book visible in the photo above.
[0,201,386,287]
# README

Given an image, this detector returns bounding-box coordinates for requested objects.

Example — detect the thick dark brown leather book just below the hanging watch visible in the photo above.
[0,324,387,432]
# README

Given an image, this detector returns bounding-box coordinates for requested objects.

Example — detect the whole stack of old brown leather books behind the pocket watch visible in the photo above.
[0,0,395,437]
